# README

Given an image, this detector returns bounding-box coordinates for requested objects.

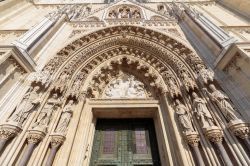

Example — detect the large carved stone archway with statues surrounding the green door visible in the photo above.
[2,26,247,165]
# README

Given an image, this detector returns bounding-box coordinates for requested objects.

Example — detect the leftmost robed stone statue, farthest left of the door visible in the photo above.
[11,86,41,124]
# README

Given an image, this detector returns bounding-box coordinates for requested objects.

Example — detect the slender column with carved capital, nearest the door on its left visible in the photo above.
[45,135,65,166]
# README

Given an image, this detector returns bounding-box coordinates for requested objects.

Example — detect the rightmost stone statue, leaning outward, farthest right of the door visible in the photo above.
[203,84,240,121]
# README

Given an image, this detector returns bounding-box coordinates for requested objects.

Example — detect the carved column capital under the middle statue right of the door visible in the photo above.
[205,126,223,143]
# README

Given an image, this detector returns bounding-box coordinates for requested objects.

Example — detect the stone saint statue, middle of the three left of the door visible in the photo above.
[33,93,61,128]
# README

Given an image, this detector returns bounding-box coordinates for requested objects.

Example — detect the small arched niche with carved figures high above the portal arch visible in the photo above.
[106,4,143,19]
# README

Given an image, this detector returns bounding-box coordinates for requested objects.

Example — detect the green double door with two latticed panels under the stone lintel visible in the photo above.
[90,119,161,166]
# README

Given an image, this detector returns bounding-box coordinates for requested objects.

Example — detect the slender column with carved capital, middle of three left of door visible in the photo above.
[18,130,45,166]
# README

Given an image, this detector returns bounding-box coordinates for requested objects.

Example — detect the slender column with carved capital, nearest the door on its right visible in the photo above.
[186,132,205,166]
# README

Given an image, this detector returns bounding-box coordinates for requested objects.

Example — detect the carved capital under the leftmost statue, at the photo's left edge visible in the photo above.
[0,124,22,140]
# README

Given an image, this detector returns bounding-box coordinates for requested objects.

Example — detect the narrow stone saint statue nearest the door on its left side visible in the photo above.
[56,100,74,134]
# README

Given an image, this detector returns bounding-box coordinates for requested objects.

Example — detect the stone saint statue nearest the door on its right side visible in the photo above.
[175,99,194,133]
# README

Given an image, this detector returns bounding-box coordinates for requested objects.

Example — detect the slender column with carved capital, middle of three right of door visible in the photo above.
[205,126,233,166]
